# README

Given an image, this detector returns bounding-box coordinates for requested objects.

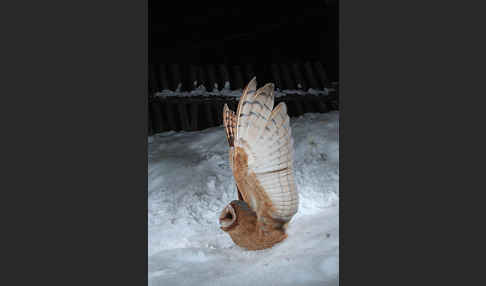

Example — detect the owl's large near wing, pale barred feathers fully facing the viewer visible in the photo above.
[233,78,299,222]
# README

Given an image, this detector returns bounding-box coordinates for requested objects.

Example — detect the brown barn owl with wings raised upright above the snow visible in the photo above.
[219,78,299,250]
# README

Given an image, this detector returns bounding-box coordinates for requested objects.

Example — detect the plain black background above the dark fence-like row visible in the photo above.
[149,1,338,81]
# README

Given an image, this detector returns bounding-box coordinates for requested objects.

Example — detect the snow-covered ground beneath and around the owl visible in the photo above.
[148,112,339,286]
